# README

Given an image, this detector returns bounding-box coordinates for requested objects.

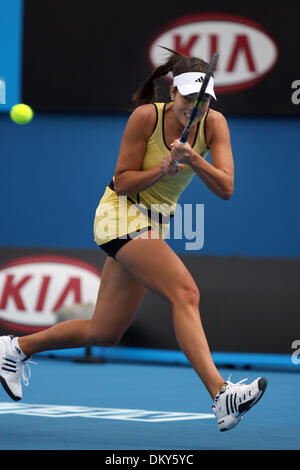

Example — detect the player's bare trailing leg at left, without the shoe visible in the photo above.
[19,257,146,356]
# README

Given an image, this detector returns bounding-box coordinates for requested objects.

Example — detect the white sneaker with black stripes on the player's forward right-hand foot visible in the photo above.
[212,377,267,431]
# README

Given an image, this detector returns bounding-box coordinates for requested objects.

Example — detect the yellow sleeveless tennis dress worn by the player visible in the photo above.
[94,103,209,250]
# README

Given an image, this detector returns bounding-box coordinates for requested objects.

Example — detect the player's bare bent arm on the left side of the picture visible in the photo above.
[115,104,180,196]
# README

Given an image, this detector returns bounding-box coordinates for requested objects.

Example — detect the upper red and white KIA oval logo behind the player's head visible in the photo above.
[149,13,278,94]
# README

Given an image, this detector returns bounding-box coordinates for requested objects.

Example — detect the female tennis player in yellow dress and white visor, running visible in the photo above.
[0,51,266,431]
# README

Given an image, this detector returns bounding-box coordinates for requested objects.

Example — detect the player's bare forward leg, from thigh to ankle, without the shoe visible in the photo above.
[116,232,224,398]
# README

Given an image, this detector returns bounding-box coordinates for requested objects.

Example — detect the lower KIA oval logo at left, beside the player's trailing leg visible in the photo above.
[0,255,100,333]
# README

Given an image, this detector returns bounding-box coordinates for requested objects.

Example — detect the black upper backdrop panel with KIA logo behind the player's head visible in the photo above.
[23,0,300,116]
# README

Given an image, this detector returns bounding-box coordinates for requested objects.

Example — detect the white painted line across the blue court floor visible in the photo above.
[0,403,215,423]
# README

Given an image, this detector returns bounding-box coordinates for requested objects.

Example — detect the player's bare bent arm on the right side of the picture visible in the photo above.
[176,110,234,200]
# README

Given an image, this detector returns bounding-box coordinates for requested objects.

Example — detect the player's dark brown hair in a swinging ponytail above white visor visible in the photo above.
[132,46,208,107]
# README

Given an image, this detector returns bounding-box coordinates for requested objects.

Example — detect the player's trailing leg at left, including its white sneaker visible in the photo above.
[0,257,146,400]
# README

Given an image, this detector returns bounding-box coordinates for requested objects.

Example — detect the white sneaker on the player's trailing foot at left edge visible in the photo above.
[0,336,30,401]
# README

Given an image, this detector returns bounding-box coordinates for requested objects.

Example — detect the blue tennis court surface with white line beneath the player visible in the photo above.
[0,348,300,451]
